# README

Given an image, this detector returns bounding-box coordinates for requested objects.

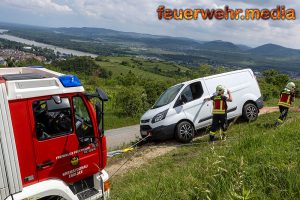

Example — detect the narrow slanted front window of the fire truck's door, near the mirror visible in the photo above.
[73,96,94,141]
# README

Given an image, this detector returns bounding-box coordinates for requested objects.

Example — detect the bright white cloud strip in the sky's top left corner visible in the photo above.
[3,0,72,13]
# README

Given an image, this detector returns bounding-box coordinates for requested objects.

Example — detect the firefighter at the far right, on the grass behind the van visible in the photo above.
[275,82,296,126]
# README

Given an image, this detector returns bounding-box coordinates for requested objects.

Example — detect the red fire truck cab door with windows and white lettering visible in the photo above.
[32,96,99,183]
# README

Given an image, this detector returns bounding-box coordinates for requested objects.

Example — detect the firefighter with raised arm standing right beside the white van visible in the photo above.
[204,85,232,141]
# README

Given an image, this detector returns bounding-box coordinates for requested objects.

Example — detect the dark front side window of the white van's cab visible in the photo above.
[181,82,203,102]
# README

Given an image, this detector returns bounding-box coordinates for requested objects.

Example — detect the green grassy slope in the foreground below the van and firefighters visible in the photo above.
[111,112,300,200]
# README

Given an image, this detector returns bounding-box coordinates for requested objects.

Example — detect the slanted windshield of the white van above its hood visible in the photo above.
[152,84,183,109]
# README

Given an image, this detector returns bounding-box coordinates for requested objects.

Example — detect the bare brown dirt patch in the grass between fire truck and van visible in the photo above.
[106,144,176,176]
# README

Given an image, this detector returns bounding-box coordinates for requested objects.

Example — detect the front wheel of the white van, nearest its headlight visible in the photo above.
[175,121,195,143]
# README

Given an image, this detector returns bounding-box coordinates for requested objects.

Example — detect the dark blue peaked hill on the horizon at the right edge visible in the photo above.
[248,44,300,56]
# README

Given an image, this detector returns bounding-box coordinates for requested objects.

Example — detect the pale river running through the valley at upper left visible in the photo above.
[0,29,98,58]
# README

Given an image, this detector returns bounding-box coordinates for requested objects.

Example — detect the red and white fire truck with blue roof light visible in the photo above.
[0,66,109,200]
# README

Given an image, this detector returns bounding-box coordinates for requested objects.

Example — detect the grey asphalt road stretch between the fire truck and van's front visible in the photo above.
[105,125,141,150]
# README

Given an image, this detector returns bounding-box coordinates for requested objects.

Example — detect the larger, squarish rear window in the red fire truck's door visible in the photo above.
[32,98,72,140]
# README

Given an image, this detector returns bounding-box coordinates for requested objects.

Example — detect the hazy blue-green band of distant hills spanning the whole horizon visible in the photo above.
[0,23,300,76]
